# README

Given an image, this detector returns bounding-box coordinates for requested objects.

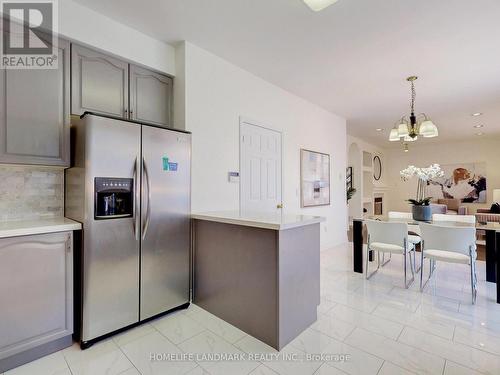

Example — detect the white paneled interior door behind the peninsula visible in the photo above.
[240,121,282,212]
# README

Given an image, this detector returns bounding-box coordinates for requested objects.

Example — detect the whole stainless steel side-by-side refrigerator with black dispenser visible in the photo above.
[65,113,191,348]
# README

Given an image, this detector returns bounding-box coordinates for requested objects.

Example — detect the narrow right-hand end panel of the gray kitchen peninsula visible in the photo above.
[278,224,320,349]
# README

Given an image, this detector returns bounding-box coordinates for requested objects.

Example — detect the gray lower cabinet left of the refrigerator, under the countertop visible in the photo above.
[0,232,73,373]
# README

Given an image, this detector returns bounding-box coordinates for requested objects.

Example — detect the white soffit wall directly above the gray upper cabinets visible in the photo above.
[59,0,175,75]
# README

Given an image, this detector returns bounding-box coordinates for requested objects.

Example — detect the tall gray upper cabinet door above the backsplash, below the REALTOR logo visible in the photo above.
[0,40,70,166]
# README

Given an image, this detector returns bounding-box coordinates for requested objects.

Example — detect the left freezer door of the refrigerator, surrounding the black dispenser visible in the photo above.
[82,115,141,342]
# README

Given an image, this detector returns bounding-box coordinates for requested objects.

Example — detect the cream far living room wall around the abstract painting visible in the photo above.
[386,139,500,213]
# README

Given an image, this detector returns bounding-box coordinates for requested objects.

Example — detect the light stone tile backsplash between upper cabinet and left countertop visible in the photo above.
[0,165,64,221]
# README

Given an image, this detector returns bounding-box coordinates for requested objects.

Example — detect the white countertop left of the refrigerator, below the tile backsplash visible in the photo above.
[0,217,82,238]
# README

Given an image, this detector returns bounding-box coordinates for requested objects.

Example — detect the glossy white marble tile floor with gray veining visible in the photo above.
[4,244,500,375]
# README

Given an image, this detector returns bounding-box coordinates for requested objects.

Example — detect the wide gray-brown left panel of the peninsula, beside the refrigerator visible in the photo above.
[193,220,278,347]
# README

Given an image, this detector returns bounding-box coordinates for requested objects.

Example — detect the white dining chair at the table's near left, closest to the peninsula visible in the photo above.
[365,220,415,289]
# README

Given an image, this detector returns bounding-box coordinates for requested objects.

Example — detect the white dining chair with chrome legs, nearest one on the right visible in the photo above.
[420,223,477,304]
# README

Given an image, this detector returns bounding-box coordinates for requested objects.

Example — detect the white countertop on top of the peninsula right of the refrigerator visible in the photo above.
[191,211,325,230]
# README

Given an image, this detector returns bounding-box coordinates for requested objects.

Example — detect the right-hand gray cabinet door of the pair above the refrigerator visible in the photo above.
[130,65,173,127]
